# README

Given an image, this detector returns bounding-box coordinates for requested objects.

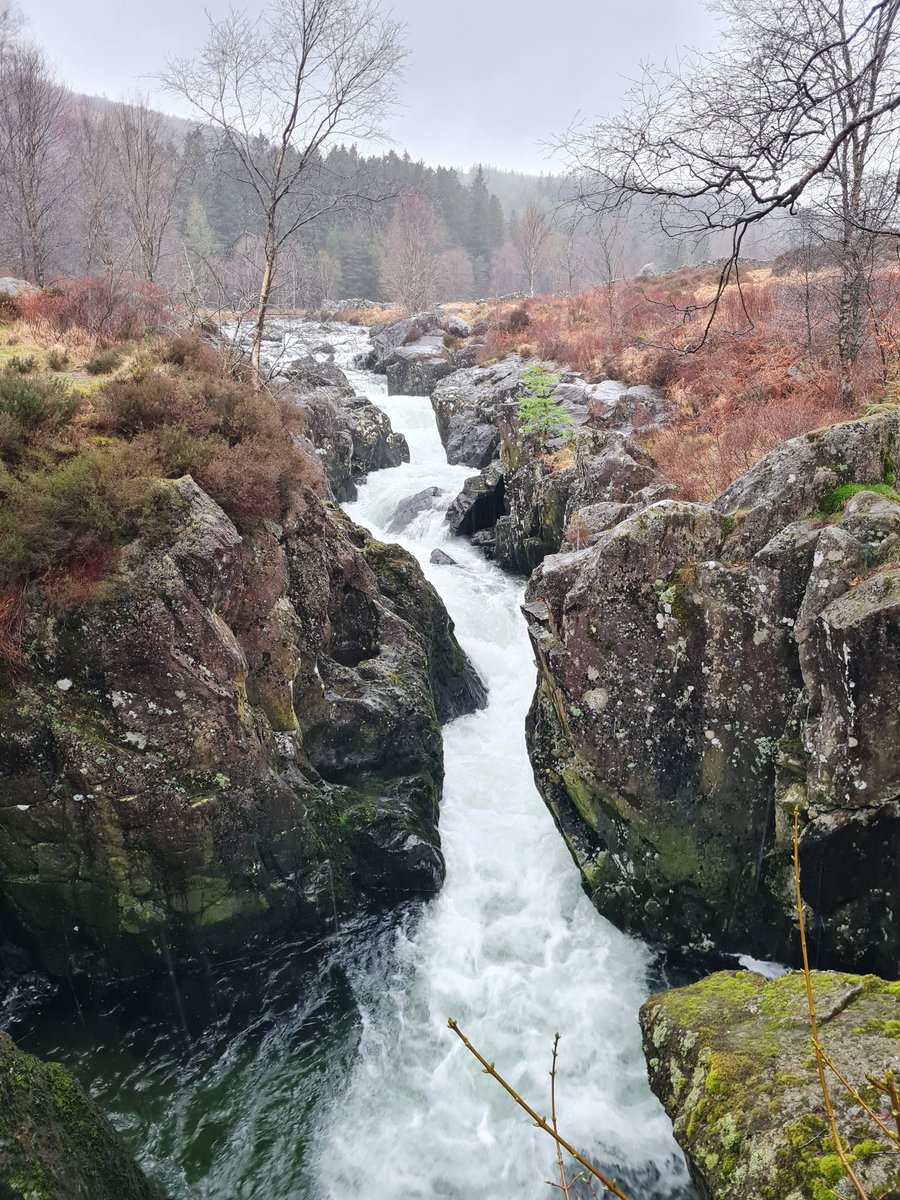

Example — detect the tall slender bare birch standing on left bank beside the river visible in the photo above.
[163,0,404,378]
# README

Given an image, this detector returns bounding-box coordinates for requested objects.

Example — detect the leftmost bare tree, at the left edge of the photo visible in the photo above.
[0,42,68,286]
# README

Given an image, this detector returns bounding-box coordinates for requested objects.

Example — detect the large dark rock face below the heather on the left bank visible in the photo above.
[0,478,484,977]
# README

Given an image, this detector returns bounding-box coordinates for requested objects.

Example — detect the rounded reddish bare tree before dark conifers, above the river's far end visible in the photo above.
[382,196,438,312]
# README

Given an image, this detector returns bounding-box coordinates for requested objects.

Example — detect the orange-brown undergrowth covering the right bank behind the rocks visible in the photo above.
[476,268,900,500]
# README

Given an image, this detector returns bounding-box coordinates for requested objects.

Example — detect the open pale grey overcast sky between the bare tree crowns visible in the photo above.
[22,0,715,170]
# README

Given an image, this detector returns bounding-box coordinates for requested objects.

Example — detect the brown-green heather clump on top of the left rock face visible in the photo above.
[0,334,320,662]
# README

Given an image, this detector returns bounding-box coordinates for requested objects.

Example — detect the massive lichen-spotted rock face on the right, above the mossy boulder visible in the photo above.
[526,414,900,976]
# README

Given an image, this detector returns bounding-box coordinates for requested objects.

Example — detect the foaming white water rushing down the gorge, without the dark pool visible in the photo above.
[303,330,690,1200]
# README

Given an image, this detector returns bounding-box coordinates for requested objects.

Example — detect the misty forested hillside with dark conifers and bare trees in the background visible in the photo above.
[0,12,768,310]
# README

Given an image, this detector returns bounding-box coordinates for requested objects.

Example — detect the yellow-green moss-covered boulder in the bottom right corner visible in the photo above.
[641,972,900,1200]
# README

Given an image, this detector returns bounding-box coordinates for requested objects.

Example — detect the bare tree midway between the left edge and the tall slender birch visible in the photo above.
[113,96,185,283]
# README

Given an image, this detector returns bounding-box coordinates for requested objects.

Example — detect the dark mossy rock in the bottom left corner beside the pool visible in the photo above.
[0,1031,163,1200]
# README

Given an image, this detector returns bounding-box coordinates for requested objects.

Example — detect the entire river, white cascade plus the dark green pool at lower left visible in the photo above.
[5,326,692,1200]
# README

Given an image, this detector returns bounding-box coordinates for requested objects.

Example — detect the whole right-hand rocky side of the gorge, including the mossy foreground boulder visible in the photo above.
[362,312,900,1198]
